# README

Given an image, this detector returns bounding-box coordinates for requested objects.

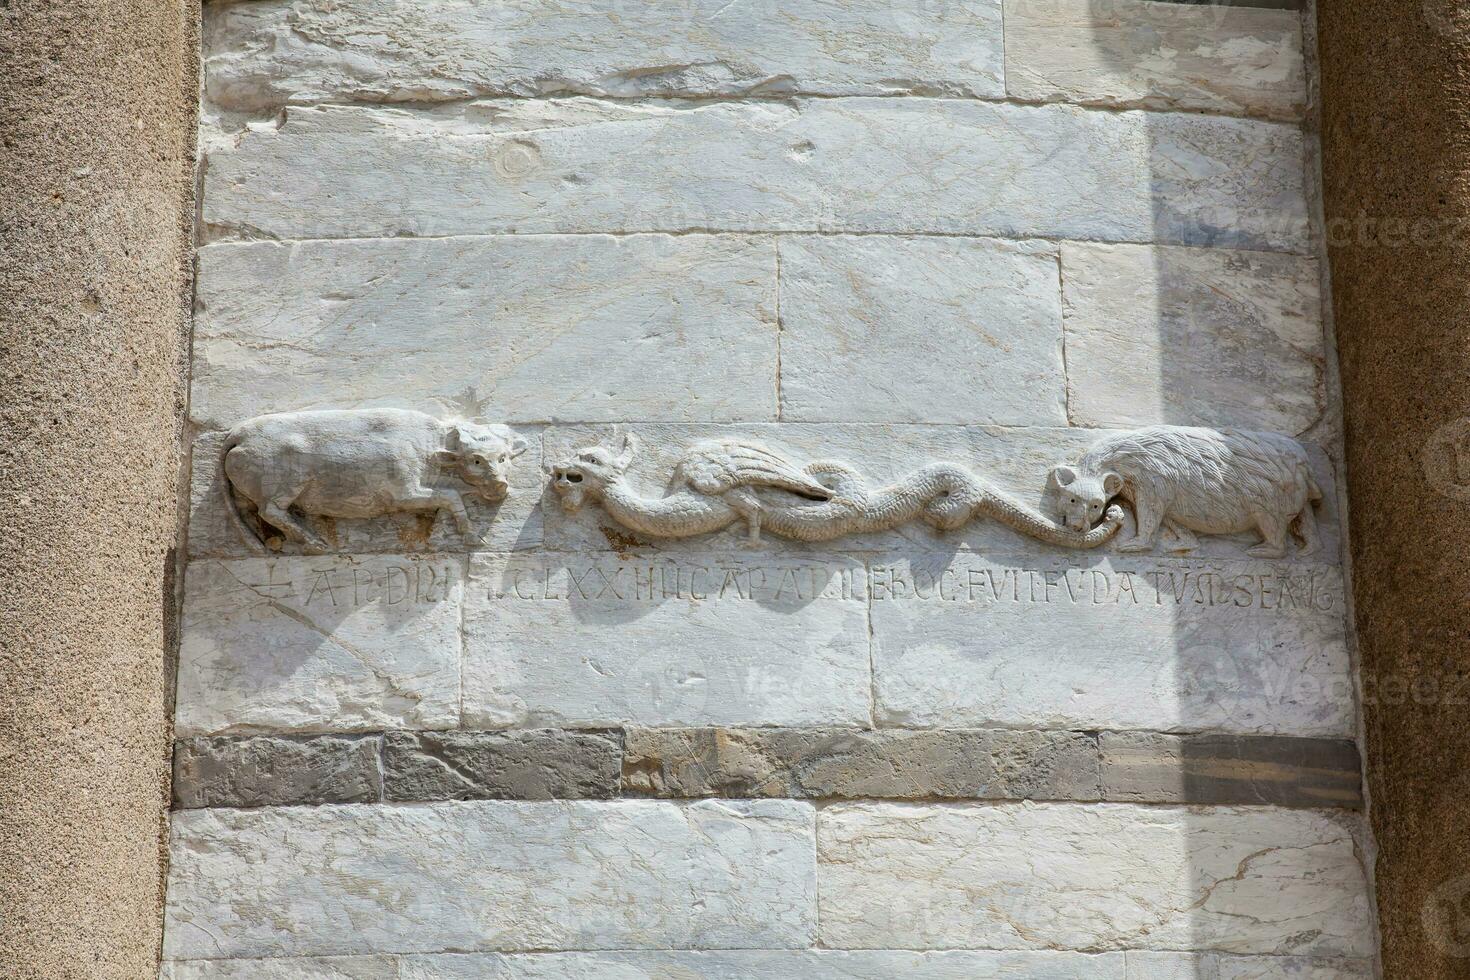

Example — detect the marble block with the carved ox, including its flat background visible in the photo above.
[188,408,542,557]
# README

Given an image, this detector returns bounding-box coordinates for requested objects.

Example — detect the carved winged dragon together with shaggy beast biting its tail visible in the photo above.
[550,426,1324,558]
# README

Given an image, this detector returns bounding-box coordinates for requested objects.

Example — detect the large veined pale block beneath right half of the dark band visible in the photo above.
[817,802,1373,958]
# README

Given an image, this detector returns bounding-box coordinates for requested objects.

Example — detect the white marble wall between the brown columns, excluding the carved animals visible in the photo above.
[163,0,1376,980]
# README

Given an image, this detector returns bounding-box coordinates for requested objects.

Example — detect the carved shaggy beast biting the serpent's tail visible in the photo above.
[1050,426,1322,558]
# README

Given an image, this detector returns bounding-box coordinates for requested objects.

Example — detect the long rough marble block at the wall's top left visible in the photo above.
[204,0,1004,110]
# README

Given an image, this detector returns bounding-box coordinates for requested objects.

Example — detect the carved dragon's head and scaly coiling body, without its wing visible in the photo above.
[556,449,1123,548]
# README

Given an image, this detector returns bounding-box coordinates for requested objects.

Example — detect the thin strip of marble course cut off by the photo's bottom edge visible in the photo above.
[162,949,1373,980]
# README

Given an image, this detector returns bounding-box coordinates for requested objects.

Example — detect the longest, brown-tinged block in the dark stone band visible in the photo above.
[623,729,1100,799]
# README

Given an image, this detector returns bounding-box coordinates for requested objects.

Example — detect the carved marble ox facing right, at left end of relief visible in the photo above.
[221,408,526,554]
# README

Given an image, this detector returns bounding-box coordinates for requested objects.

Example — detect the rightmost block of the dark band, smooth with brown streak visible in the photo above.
[1100,732,1363,808]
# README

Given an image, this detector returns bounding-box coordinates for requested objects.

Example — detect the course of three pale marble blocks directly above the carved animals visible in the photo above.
[190,235,1324,434]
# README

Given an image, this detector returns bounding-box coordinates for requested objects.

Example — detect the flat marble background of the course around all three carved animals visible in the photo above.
[188,422,1341,564]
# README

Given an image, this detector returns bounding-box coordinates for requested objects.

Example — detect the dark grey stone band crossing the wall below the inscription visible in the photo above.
[173,729,1363,810]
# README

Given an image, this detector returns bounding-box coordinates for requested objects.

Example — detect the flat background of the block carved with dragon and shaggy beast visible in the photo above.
[542,423,1339,564]
